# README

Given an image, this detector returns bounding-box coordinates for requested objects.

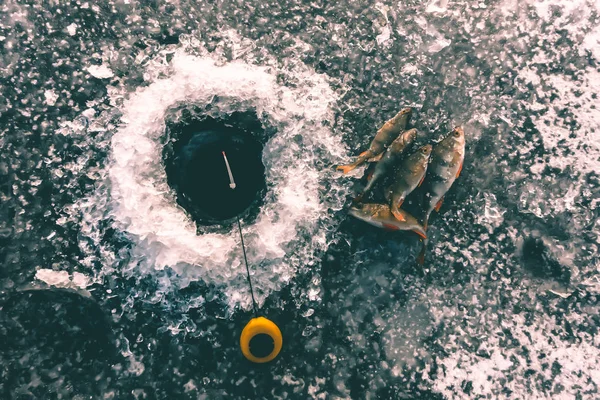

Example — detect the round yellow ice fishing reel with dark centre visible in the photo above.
[240,317,283,364]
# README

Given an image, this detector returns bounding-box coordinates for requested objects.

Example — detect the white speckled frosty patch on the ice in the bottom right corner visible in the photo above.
[434,315,600,399]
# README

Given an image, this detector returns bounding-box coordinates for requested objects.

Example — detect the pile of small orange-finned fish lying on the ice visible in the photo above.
[337,108,465,264]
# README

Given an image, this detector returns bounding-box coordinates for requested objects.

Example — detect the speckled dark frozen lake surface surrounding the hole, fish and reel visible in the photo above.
[0,0,600,399]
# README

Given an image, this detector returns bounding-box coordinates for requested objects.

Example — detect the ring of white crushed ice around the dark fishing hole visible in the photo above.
[108,50,349,308]
